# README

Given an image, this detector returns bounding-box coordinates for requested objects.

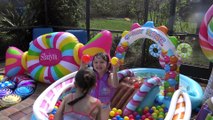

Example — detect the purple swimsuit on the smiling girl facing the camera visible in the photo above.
[90,72,116,104]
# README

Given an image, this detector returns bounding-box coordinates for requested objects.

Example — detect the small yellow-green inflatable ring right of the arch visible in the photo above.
[177,43,192,58]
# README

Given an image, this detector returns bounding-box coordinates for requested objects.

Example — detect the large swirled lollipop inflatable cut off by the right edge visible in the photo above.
[199,5,213,101]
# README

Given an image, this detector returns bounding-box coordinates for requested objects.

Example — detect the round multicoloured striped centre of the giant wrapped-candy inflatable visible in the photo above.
[27,32,80,83]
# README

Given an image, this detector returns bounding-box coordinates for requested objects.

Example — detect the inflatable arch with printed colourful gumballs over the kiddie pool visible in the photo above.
[115,21,181,101]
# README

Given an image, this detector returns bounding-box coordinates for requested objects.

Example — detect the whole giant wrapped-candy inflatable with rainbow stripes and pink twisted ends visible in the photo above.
[5,30,112,83]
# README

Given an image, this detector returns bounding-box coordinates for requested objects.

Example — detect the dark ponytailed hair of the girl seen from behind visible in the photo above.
[68,69,96,105]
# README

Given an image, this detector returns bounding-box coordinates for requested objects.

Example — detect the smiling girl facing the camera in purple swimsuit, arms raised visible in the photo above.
[80,52,120,120]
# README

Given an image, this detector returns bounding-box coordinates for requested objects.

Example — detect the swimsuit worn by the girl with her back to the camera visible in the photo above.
[63,94,99,120]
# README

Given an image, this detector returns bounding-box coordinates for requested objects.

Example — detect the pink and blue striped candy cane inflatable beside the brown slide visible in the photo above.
[123,77,161,116]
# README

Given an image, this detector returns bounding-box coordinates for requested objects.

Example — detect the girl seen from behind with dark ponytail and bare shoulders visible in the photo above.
[55,69,101,120]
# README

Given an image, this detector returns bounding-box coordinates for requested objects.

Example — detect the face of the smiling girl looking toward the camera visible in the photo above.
[93,56,109,73]
